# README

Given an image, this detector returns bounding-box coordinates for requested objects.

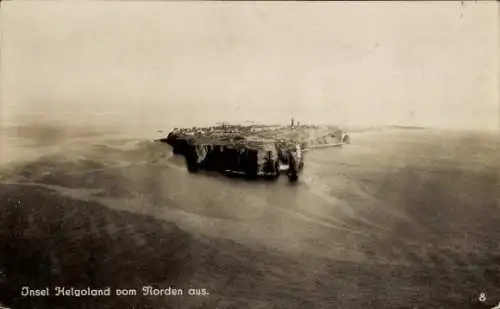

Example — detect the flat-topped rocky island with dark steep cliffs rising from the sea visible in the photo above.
[159,125,346,181]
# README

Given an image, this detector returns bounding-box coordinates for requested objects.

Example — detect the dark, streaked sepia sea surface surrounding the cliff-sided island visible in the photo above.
[0,121,500,309]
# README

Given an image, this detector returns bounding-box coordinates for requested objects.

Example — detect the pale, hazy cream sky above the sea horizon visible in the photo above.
[0,1,500,129]
